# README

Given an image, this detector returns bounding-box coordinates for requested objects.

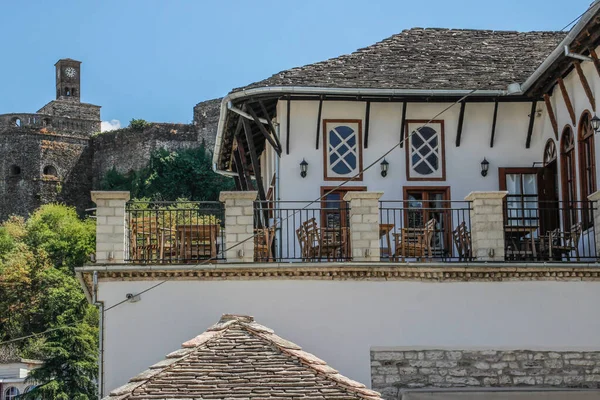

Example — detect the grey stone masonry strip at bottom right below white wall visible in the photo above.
[371,349,600,400]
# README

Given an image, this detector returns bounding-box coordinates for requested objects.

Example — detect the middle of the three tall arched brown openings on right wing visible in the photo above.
[560,125,577,229]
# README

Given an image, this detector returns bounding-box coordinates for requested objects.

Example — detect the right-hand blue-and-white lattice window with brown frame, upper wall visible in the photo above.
[407,122,445,180]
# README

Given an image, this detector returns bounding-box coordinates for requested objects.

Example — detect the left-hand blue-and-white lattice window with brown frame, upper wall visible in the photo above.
[323,120,362,180]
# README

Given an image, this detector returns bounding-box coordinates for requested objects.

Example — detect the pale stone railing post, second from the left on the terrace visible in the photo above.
[219,191,258,262]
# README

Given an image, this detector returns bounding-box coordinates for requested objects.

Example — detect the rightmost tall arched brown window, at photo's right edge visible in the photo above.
[578,111,596,229]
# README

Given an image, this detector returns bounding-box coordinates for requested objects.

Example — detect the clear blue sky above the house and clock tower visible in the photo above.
[0,0,591,129]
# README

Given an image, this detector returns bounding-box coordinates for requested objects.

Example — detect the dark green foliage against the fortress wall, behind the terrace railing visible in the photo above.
[101,144,233,201]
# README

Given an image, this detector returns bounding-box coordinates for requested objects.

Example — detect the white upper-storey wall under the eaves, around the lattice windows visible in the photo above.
[263,48,600,206]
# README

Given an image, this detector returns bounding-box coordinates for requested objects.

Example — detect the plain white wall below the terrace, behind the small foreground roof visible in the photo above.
[99,280,600,390]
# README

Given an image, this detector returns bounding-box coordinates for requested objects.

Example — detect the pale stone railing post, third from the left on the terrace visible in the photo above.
[344,192,383,261]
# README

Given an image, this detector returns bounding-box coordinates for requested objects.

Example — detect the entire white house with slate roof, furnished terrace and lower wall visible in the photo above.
[77,2,600,399]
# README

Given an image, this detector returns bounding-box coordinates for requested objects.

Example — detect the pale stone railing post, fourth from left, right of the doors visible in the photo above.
[465,191,508,261]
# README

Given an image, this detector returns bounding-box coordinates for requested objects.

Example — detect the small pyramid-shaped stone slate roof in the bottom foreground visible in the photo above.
[105,315,381,400]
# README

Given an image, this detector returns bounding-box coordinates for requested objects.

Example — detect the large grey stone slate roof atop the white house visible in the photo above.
[233,28,566,92]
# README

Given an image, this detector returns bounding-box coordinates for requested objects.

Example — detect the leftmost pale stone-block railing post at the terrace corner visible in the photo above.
[92,191,130,264]
